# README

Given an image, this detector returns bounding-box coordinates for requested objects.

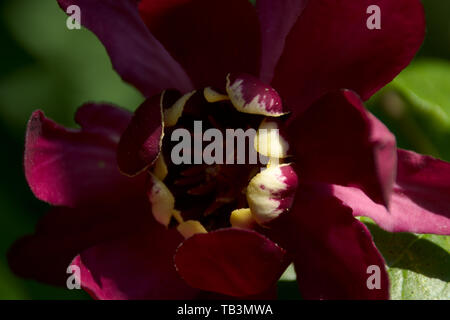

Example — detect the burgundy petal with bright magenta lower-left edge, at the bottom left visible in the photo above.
[72,223,199,300]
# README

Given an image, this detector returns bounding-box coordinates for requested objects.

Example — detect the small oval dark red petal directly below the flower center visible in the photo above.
[175,228,289,297]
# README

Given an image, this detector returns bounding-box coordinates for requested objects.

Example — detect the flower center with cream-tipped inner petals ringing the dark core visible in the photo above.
[149,75,297,237]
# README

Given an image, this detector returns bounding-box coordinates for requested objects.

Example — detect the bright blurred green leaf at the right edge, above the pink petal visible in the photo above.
[368,59,450,160]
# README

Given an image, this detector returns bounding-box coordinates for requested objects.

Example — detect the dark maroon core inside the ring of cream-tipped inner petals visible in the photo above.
[162,92,264,231]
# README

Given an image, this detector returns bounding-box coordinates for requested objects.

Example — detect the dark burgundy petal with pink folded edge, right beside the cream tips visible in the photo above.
[290,90,396,205]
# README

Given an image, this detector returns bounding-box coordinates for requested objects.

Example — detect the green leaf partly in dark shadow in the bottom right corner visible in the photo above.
[361,218,450,300]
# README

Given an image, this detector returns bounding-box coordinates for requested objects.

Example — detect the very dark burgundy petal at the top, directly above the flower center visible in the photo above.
[139,0,260,88]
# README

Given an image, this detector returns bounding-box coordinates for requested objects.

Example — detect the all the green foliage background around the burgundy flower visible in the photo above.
[0,0,450,299]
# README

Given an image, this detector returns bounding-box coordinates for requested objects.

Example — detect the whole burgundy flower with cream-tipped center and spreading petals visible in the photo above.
[9,0,450,299]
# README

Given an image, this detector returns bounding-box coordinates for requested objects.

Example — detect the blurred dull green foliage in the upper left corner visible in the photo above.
[0,0,142,134]
